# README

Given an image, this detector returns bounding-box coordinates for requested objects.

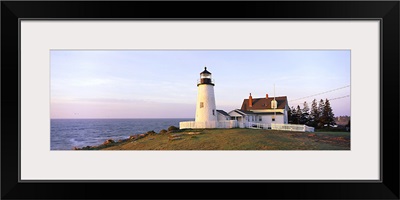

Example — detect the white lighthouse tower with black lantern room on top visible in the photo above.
[195,67,217,122]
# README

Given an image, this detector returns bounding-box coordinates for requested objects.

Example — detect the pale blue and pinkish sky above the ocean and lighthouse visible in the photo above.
[50,50,351,119]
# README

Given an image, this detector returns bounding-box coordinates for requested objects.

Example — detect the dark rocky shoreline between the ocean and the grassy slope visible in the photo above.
[72,126,181,150]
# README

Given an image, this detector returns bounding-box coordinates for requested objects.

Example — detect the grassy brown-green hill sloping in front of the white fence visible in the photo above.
[83,128,350,150]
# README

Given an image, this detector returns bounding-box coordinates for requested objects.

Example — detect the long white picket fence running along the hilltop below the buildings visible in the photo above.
[179,120,314,132]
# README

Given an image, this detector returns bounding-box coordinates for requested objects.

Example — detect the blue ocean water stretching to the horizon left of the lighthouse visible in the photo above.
[50,118,194,150]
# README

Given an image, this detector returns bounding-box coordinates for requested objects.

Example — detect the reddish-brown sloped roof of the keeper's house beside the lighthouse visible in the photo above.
[240,96,287,111]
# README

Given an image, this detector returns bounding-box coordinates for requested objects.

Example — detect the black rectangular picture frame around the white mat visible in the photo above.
[1,1,400,199]
